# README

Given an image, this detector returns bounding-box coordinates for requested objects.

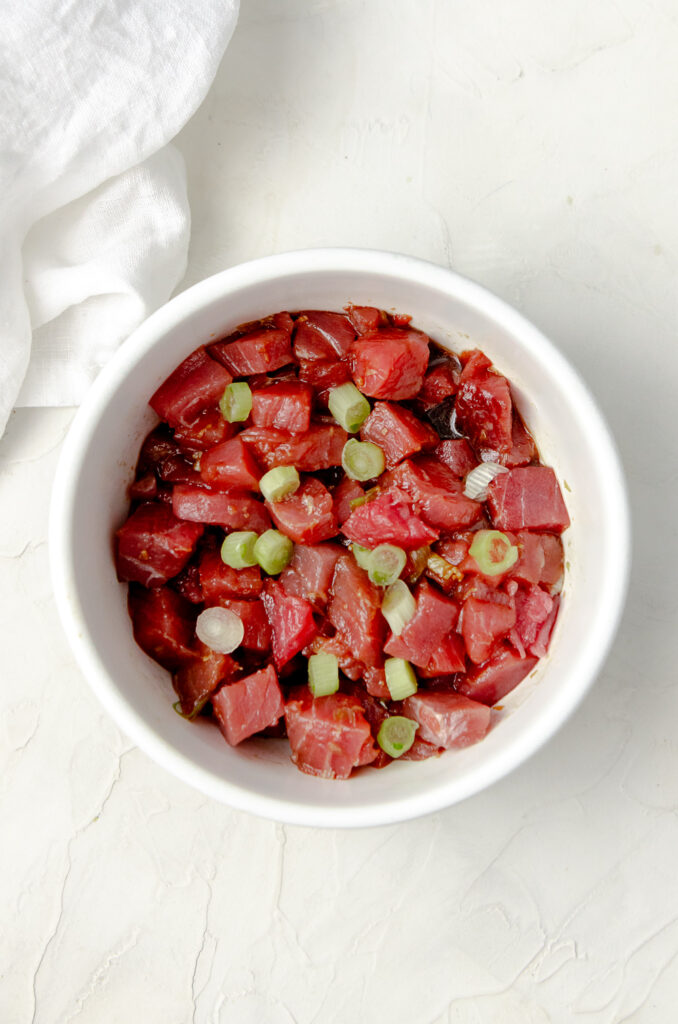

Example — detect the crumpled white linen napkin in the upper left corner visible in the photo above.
[0,0,239,434]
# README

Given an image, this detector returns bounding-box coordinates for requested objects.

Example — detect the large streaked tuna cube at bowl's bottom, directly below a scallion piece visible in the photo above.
[285,687,377,778]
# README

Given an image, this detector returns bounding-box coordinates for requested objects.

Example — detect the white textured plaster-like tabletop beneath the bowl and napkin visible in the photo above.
[0,0,678,1024]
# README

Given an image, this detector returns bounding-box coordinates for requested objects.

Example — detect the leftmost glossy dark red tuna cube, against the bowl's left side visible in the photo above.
[116,502,205,587]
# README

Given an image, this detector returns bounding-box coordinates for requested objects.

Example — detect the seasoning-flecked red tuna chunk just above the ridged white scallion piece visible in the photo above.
[455,365,513,455]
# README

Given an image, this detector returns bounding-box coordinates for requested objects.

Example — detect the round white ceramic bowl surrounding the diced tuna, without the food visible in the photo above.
[50,249,630,826]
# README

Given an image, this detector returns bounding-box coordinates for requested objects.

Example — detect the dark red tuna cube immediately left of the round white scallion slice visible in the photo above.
[127,586,196,672]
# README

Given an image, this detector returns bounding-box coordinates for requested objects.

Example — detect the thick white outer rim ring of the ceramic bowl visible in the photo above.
[48,248,631,827]
